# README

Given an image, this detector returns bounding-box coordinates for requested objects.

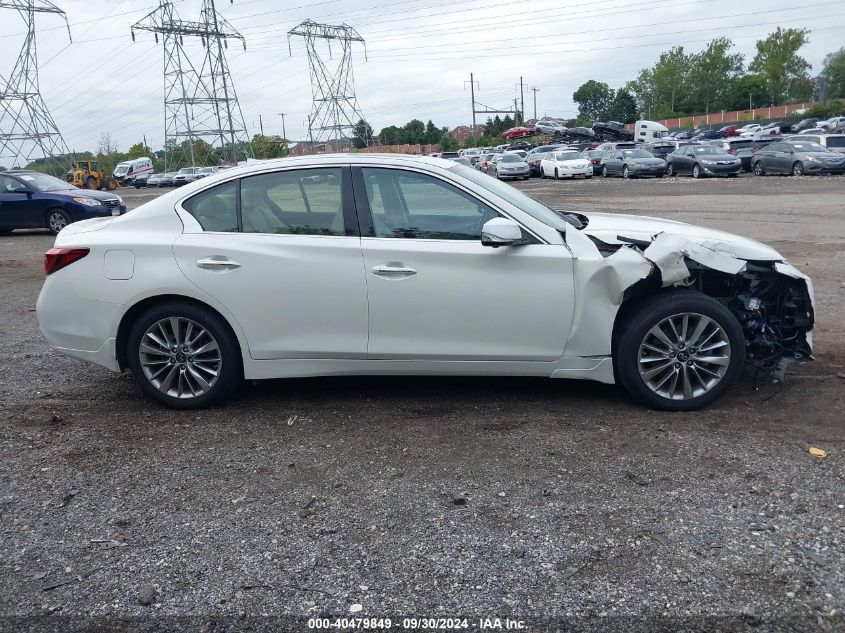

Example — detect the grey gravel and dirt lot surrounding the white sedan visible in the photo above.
[0,177,845,631]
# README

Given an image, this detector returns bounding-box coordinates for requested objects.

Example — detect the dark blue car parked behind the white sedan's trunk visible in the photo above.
[0,170,126,234]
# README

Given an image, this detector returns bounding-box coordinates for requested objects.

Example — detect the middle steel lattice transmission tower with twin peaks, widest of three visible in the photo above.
[132,0,252,169]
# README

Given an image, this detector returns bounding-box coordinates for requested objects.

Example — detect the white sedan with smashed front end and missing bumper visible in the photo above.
[37,155,814,410]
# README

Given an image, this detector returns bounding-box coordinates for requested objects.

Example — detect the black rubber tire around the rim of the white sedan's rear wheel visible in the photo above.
[126,301,243,409]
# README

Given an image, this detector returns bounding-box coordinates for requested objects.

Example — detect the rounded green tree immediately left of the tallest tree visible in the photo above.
[689,37,743,114]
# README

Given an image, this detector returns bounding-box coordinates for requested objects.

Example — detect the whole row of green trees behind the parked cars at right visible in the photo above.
[572,27,845,123]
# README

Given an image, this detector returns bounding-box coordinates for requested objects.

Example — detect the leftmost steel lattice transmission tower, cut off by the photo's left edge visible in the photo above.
[0,0,70,167]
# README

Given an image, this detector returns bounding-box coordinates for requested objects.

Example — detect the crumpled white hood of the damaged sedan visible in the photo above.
[583,213,783,261]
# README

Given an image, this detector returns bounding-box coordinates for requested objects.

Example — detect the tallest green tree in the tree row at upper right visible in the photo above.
[748,27,812,105]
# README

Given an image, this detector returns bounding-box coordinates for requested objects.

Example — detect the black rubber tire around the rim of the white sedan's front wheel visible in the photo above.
[614,290,745,411]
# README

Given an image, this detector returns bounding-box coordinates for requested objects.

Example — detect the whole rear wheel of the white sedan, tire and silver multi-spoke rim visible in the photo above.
[126,302,243,409]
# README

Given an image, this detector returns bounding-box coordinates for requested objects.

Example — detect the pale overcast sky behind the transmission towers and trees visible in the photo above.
[0,0,845,151]
